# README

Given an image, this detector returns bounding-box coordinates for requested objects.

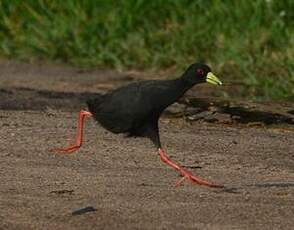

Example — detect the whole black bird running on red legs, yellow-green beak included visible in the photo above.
[54,63,222,187]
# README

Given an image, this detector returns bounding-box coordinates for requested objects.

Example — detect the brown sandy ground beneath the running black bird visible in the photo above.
[0,62,294,229]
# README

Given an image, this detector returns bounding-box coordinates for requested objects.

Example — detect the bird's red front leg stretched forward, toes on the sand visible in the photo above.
[158,148,224,188]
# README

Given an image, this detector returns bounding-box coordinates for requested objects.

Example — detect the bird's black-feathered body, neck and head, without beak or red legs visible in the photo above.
[87,64,214,147]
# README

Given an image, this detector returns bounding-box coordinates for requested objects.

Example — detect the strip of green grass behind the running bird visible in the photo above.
[0,0,294,100]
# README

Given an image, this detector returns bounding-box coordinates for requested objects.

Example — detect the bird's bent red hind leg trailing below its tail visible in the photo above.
[52,110,93,154]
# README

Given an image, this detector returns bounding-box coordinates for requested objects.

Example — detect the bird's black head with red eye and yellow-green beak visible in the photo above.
[182,63,222,85]
